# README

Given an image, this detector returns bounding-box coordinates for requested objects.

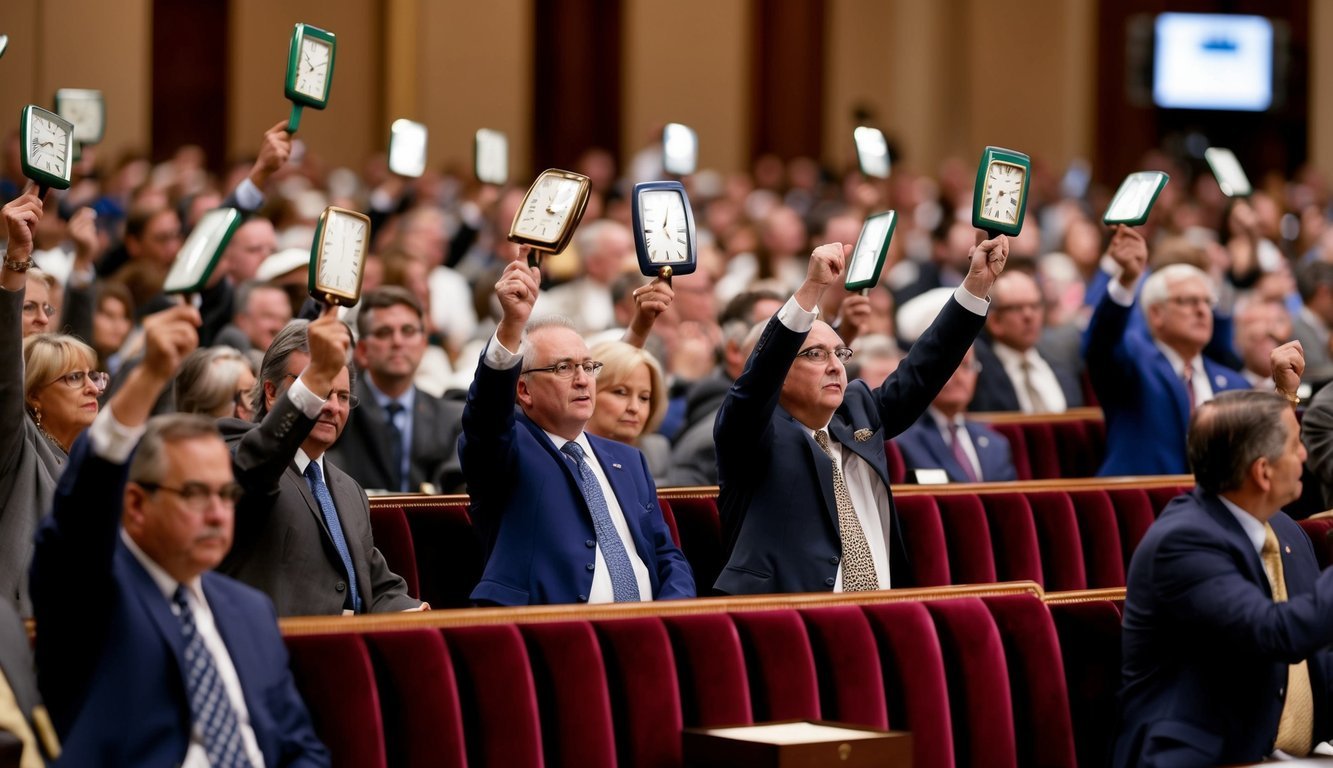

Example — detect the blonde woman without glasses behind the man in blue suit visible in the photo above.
[587,341,670,485]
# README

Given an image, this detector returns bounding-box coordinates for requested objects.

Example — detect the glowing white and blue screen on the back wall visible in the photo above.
[1153,13,1273,112]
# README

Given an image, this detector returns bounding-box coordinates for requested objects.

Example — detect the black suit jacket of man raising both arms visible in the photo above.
[714,299,984,595]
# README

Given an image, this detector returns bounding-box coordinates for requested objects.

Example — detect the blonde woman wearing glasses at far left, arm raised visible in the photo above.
[0,184,108,616]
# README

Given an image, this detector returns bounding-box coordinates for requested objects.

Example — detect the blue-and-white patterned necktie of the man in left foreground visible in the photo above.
[172,587,251,768]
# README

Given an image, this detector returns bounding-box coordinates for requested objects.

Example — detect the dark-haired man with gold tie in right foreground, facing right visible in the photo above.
[1114,343,1333,767]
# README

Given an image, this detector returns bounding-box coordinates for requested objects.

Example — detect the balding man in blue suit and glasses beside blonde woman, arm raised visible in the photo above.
[459,256,694,605]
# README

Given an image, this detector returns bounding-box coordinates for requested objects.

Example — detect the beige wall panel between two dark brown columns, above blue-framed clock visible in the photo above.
[621,0,750,172]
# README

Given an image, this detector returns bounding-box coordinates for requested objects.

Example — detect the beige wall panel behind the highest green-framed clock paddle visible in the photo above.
[228,0,389,169]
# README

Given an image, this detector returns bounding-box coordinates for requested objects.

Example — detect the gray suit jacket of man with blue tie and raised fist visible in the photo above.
[217,396,421,616]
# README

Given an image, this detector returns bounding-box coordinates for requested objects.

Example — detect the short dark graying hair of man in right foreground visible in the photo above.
[1186,389,1292,493]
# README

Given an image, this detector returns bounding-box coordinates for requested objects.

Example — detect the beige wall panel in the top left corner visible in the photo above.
[0,0,152,166]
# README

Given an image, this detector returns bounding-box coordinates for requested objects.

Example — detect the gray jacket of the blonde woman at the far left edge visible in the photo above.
[0,289,69,616]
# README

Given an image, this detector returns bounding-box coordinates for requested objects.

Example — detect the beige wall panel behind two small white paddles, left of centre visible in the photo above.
[415,0,537,178]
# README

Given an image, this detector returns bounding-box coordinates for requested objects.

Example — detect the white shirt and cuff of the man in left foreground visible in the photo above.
[88,405,264,768]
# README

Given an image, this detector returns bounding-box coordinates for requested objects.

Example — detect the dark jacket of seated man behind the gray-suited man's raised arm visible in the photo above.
[329,376,463,493]
